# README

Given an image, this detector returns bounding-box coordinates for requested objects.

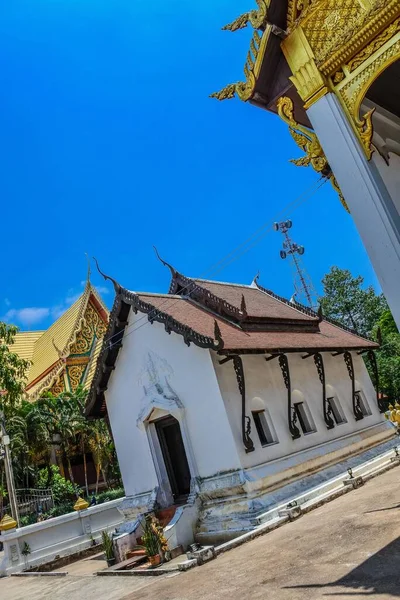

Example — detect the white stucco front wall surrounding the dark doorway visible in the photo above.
[106,311,240,496]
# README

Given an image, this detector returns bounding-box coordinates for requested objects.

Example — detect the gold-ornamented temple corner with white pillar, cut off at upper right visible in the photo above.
[212,0,400,327]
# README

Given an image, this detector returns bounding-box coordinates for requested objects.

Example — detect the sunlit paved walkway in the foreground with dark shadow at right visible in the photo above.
[0,468,400,600]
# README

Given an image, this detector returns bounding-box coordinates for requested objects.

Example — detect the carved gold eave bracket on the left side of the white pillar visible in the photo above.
[277,96,350,212]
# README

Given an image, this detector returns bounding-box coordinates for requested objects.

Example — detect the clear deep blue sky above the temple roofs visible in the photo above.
[0,0,377,329]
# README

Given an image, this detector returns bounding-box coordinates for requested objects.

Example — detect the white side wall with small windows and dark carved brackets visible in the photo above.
[214,353,384,468]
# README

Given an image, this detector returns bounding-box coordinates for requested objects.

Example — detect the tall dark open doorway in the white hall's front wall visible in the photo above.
[155,417,190,502]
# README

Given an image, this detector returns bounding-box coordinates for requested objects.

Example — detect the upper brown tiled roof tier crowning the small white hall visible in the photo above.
[194,279,318,321]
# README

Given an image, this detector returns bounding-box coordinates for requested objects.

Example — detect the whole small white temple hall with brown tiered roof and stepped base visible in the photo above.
[86,263,394,543]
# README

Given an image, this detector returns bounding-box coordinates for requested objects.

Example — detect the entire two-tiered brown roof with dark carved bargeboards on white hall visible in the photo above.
[86,265,378,417]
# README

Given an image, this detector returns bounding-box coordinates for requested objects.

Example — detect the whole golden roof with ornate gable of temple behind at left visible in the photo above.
[10,281,108,401]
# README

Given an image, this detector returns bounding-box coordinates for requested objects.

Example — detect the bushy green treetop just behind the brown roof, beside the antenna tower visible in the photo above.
[320,267,390,337]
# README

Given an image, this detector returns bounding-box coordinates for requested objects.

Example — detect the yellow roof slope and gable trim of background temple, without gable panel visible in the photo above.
[10,281,108,400]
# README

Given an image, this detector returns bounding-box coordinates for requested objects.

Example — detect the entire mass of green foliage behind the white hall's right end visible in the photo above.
[320,267,400,401]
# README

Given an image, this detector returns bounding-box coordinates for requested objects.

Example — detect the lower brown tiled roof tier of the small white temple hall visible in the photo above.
[139,294,378,353]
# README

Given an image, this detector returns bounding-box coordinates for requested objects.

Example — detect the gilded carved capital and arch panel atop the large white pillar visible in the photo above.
[282,0,400,160]
